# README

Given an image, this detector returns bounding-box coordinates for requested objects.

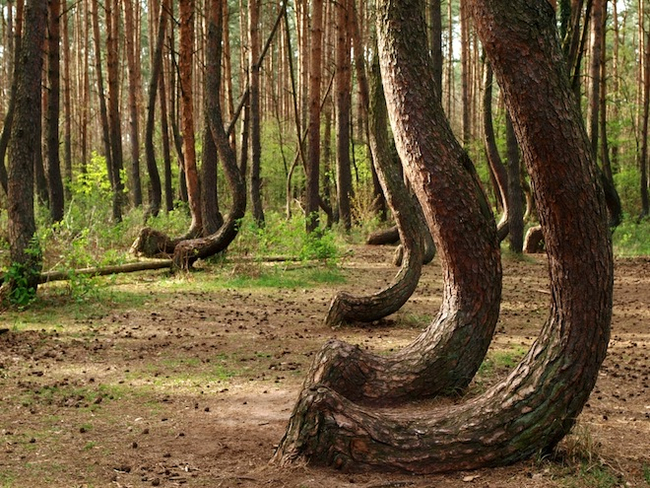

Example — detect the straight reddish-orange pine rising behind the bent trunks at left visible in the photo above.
[178,0,203,236]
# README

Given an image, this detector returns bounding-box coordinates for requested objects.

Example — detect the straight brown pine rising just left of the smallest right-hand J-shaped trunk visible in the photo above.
[335,0,354,230]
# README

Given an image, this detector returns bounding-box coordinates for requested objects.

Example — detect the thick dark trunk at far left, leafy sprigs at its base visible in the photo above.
[7,0,47,290]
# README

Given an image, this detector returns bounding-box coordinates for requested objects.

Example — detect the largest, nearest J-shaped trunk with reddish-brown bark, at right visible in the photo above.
[275,0,613,473]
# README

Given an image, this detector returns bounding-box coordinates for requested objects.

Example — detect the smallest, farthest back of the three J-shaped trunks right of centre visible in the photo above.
[325,55,431,327]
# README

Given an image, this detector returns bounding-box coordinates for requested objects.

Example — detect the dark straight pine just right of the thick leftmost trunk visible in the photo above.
[46,0,64,222]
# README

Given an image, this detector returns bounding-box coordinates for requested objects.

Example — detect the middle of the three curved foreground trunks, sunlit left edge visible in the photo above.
[278,2,501,403]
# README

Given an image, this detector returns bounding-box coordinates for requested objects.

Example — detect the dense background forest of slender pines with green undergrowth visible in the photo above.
[0,0,650,280]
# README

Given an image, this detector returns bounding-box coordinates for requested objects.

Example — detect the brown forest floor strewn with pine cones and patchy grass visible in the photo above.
[0,246,650,488]
